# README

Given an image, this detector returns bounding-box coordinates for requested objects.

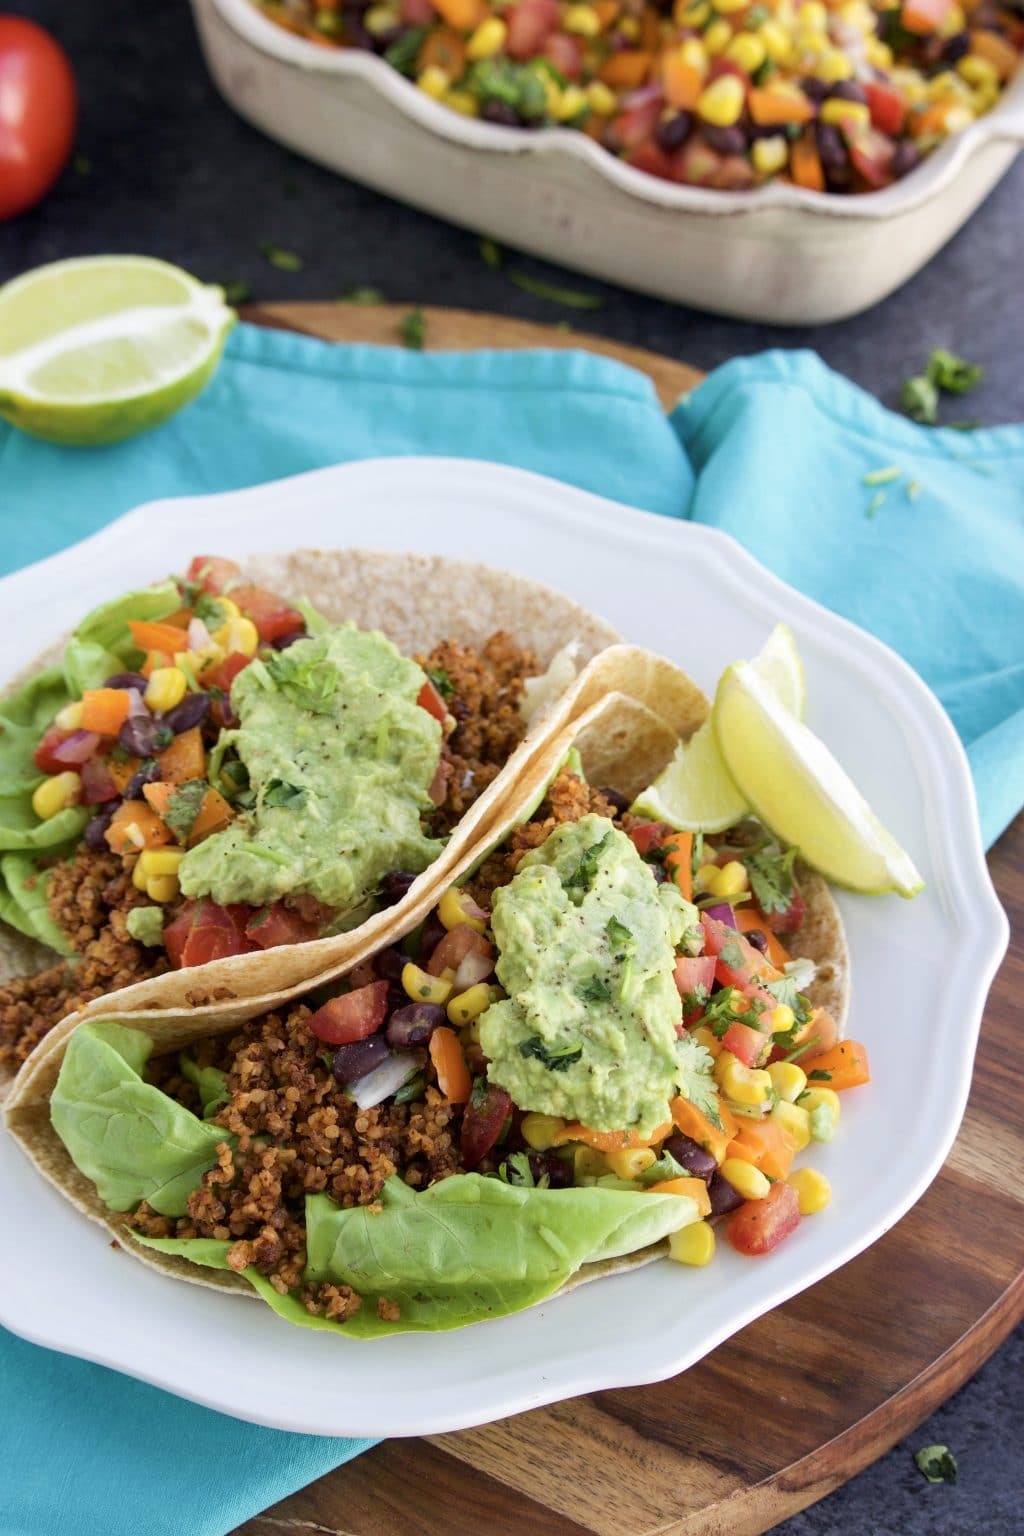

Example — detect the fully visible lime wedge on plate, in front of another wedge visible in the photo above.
[711,662,924,895]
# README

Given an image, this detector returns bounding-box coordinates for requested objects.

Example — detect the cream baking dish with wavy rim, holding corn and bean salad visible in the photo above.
[192,0,1024,326]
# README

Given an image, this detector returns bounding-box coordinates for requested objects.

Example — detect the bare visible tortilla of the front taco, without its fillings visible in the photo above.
[5,685,849,1320]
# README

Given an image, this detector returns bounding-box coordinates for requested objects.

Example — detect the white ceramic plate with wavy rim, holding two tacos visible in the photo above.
[0,459,1009,1435]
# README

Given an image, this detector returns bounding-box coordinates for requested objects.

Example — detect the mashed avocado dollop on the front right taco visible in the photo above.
[481,816,686,1134]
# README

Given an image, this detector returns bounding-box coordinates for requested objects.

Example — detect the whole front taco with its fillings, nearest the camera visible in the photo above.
[6,659,857,1338]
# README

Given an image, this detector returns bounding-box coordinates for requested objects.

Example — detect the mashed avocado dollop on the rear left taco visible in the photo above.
[180,625,441,928]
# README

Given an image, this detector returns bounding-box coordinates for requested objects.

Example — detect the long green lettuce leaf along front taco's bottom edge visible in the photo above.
[137,1174,697,1338]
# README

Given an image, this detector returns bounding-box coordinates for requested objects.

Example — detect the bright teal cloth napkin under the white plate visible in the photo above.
[0,326,1024,1536]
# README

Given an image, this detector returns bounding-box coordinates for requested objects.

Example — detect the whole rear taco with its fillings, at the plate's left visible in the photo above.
[0,550,641,1081]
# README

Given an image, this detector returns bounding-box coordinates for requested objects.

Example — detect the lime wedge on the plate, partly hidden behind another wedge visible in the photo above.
[631,624,804,833]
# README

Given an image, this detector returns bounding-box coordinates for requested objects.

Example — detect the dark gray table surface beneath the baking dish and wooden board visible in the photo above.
[0,0,1024,1536]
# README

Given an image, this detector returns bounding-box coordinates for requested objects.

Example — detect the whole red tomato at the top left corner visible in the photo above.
[0,15,78,220]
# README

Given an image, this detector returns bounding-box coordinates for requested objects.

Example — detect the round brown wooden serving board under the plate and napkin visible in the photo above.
[238,304,1024,1536]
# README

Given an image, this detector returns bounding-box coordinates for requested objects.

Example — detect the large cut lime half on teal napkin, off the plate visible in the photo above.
[0,257,235,445]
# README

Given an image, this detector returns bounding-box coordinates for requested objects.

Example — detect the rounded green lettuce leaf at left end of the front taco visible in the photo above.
[51,1021,235,1217]
